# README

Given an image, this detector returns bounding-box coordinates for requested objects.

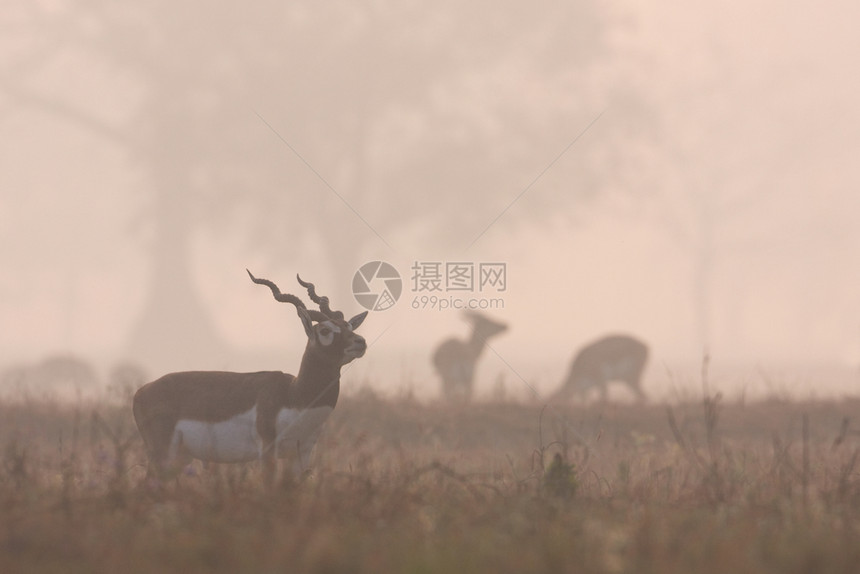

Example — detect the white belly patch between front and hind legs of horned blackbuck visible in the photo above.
[170,406,261,462]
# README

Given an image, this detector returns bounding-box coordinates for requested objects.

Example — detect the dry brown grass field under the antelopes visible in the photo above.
[0,393,860,574]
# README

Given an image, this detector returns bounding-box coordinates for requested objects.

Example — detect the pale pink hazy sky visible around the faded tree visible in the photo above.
[0,1,860,400]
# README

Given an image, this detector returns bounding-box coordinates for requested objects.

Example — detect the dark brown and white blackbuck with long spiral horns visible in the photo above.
[133,271,367,486]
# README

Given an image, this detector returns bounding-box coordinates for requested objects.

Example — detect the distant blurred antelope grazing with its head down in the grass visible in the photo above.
[551,335,648,401]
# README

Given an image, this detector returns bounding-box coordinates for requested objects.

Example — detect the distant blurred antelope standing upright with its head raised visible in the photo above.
[433,311,508,401]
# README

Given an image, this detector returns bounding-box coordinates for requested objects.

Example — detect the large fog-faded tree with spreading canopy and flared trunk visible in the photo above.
[0,1,644,364]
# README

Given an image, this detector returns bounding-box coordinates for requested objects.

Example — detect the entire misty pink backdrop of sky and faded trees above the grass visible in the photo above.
[0,0,860,397]
